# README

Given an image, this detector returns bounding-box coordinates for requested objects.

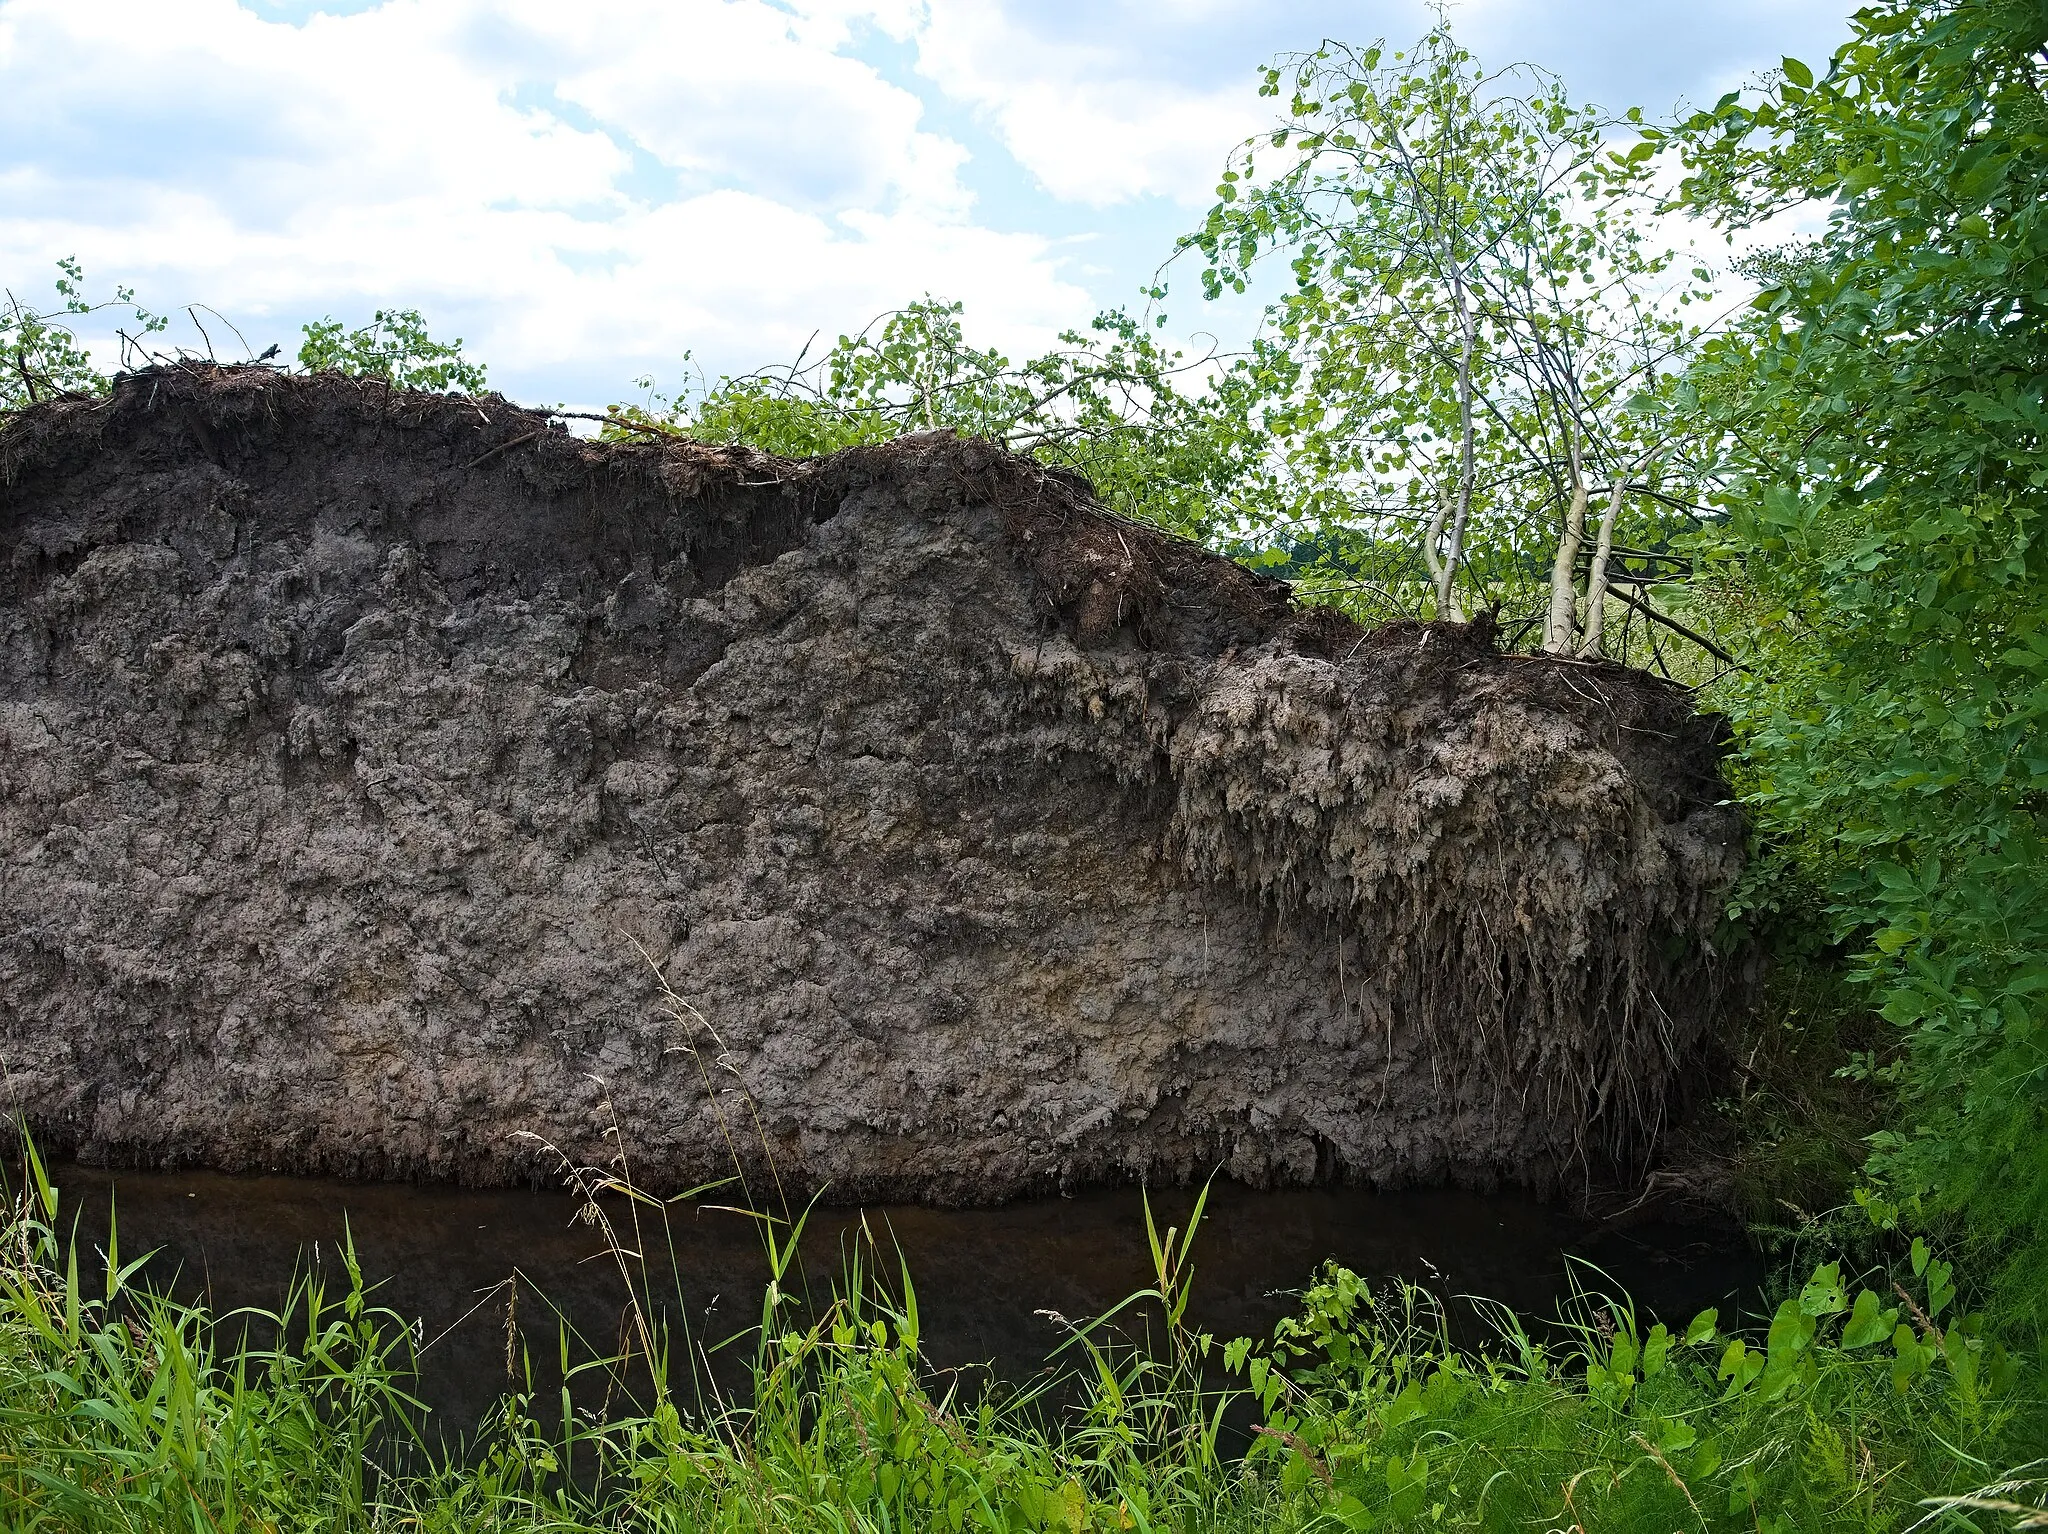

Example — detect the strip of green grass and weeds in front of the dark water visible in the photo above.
[0,1149,2048,1534]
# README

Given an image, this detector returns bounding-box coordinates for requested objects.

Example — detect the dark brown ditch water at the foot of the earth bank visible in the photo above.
[53,1165,1761,1432]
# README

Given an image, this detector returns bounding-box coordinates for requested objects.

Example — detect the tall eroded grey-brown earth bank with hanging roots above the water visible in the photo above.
[0,369,1741,1202]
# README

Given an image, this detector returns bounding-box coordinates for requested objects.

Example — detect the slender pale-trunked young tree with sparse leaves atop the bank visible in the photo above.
[1182,27,1706,619]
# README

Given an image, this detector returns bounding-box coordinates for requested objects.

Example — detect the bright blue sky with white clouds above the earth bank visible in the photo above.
[0,0,1853,406]
